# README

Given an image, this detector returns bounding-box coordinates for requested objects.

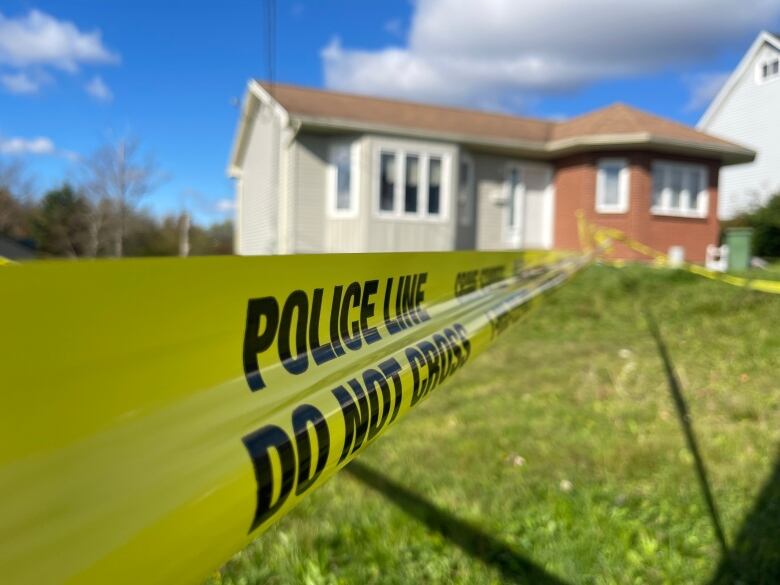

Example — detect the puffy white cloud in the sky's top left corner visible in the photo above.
[0,10,119,71]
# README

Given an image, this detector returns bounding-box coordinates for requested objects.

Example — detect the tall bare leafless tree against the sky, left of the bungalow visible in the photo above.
[84,138,162,257]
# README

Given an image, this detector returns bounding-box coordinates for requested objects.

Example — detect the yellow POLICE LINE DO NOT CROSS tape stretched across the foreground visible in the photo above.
[0,252,589,584]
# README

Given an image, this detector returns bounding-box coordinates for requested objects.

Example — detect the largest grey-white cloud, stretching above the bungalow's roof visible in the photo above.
[321,0,780,104]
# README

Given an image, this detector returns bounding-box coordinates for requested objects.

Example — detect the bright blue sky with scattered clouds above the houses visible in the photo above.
[0,0,780,221]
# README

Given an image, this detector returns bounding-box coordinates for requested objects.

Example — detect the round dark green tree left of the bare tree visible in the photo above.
[32,183,91,258]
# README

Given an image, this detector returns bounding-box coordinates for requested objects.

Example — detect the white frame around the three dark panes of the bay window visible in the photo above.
[371,143,452,223]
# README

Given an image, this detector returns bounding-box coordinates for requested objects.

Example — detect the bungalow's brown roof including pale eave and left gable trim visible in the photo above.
[232,82,755,175]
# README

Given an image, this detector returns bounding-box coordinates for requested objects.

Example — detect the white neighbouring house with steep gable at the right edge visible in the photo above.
[697,32,780,219]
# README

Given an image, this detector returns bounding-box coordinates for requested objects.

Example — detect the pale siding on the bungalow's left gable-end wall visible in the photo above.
[236,107,280,255]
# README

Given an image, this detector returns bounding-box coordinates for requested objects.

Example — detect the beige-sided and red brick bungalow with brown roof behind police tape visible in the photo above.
[229,81,754,261]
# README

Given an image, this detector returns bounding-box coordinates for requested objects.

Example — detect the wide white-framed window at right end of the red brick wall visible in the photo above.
[651,161,707,217]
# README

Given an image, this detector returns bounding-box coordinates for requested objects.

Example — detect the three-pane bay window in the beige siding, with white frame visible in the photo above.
[374,145,449,219]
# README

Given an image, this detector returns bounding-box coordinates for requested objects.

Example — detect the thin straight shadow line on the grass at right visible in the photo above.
[643,309,729,563]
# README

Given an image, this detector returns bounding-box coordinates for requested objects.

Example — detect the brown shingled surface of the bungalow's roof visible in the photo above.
[253,84,752,159]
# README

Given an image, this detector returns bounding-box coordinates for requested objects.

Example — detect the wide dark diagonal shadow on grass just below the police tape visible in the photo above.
[344,461,565,585]
